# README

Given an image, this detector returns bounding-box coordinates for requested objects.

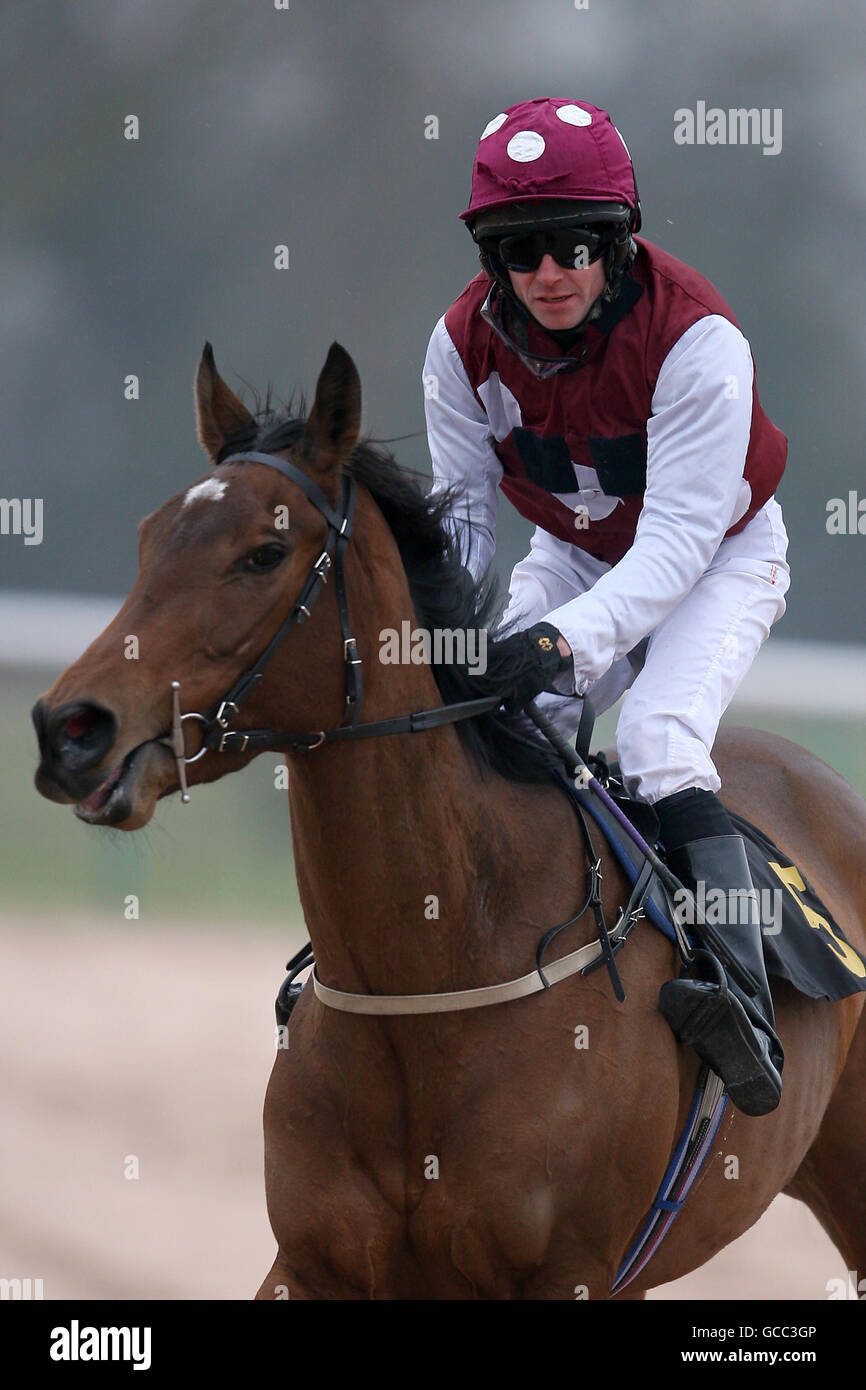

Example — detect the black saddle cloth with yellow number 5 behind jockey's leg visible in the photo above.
[577,763,866,999]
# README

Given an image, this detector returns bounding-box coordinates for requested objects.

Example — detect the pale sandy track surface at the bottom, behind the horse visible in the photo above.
[0,917,845,1300]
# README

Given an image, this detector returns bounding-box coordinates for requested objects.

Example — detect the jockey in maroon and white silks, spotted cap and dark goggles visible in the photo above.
[424,99,790,1115]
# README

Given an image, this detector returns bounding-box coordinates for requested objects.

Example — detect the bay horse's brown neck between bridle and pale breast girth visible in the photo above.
[283,522,539,994]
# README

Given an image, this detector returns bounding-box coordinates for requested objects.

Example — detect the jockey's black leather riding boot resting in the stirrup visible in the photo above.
[656,792,784,1115]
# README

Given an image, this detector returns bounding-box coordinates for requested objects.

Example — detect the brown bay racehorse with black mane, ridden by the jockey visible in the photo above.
[33,343,866,1300]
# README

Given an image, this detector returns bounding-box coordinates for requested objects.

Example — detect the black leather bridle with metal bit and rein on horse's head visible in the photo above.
[160,450,502,803]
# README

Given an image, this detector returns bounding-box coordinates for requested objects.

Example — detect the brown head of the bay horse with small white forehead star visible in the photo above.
[32,343,360,830]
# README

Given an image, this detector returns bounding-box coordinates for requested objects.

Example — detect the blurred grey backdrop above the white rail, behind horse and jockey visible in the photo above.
[0,0,866,641]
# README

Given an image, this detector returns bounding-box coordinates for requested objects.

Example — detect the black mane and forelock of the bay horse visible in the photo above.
[217,392,557,783]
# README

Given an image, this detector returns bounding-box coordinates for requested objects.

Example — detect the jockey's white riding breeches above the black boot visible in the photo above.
[503,498,791,802]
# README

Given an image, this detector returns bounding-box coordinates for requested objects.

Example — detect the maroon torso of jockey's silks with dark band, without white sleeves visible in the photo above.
[445,238,787,564]
